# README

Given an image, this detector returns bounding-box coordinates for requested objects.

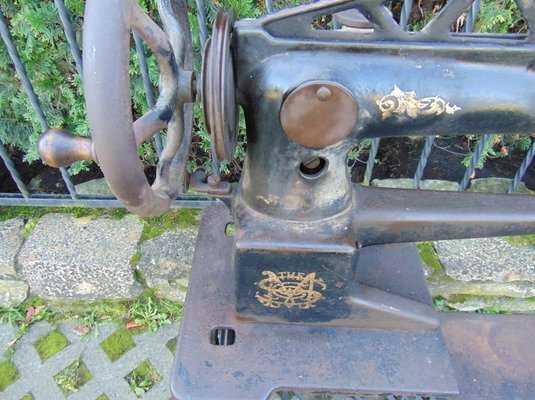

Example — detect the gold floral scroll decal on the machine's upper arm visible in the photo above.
[377,85,461,119]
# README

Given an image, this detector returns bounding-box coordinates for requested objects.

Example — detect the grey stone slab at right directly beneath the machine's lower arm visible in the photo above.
[434,238,535,283]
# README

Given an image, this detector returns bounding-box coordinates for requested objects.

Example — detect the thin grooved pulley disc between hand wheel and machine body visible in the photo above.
[202,10,239,161]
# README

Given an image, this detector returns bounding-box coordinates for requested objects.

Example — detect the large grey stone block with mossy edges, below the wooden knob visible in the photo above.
[18,214,143,300]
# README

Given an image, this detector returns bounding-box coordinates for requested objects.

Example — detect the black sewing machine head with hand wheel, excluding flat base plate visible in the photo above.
[36,0,535,398]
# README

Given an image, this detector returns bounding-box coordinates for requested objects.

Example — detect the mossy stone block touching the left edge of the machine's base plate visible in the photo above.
[137,228,197,301]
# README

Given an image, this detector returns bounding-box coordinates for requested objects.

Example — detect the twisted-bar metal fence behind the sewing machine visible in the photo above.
[0,0,535,212]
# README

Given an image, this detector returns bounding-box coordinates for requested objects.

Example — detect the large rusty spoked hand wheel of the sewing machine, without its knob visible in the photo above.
[84,0,193,215]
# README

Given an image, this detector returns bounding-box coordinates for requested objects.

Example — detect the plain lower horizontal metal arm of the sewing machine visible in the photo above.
[353,186,535,246]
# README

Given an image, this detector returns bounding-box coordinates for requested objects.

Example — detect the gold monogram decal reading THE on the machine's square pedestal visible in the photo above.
[255,271,327,310]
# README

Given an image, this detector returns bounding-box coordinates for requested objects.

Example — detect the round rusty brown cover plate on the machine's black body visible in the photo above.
[280,82,358,148]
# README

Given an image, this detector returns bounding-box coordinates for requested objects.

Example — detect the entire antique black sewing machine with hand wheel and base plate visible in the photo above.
[40,0,535,400]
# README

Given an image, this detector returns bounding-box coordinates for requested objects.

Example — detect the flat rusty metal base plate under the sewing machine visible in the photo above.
[171,206,535,400]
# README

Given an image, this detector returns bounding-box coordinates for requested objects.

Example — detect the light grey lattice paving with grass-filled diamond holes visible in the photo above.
[0,322,178,400]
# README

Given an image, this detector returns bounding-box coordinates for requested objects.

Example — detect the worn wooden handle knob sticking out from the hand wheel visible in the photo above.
[37,128,97,168]
